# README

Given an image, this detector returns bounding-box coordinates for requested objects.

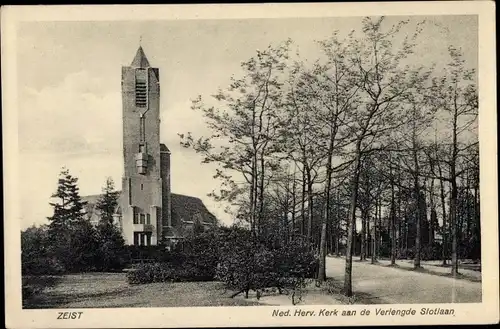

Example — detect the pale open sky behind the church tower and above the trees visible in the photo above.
[17,16,478,228]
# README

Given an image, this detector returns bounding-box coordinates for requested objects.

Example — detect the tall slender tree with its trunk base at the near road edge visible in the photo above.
[338,17,427,296]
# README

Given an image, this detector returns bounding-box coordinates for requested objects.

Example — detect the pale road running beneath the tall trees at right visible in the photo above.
[326,257,481,304]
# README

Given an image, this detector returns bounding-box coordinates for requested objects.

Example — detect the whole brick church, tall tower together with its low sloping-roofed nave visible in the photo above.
[83,47,217,246]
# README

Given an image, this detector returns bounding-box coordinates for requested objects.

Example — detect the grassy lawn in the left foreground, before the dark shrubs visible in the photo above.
[23,273,260,309]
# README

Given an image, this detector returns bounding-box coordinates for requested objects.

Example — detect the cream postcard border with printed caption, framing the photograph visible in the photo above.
[1,1,499,328]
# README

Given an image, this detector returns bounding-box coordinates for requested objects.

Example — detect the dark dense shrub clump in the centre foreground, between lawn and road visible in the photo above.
[127,228,319,293]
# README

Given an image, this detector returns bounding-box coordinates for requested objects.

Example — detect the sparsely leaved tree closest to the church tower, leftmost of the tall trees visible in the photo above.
[180,40,291,234]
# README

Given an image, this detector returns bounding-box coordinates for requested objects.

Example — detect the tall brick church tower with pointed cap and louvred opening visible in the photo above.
[120,47,171,246]
